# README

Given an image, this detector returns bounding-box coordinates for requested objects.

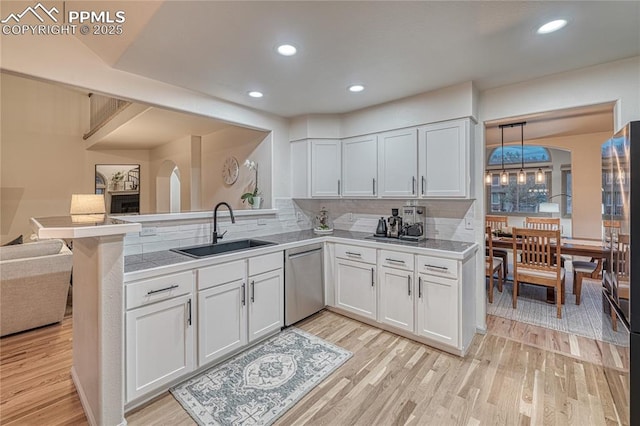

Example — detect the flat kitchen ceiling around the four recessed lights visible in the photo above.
[78,1,640,117]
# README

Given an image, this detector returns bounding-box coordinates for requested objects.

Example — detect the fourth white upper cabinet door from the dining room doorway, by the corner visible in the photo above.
[311,140,342,197]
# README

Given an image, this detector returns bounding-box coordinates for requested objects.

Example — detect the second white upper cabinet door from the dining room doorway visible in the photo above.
[378,129,418,197]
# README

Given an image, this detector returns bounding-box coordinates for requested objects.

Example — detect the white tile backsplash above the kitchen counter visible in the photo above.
[124,198,475,256]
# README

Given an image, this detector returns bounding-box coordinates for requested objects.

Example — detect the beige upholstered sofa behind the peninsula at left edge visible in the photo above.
[0,240,73,336]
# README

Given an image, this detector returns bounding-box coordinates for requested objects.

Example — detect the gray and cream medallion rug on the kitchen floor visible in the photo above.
[171,328,352,425]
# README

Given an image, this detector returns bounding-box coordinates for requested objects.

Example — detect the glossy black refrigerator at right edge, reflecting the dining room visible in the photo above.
[602,121,640,424]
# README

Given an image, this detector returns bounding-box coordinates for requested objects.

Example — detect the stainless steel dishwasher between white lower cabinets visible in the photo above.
[284,243,324,326]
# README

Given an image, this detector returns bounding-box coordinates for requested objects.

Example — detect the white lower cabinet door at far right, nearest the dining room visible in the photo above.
[417,274,459,348]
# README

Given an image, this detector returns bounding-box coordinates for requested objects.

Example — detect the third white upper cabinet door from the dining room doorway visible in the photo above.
[342,135,378,197]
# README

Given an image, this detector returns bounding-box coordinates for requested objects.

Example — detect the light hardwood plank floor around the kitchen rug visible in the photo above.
[0,311,629,426]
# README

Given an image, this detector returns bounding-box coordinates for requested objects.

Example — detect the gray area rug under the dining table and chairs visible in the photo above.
[487,280,629,346]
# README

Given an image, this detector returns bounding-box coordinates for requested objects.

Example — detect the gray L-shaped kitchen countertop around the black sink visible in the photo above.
[124,229,475,273]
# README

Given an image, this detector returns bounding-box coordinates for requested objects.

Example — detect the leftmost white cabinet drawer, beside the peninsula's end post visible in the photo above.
[126,271,193,310]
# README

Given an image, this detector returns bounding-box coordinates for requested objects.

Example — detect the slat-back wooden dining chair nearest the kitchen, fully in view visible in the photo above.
[512,228,564,318]
